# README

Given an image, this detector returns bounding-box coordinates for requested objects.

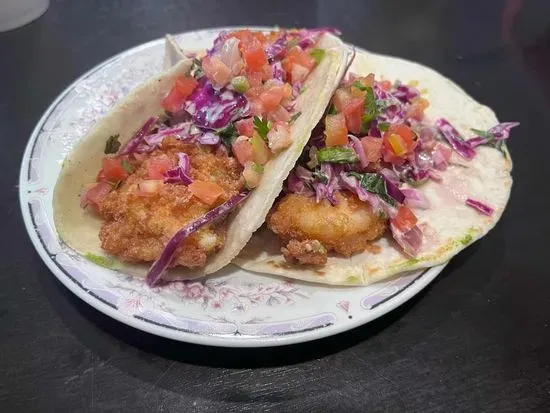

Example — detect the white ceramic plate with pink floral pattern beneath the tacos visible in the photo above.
[19,29,444,347]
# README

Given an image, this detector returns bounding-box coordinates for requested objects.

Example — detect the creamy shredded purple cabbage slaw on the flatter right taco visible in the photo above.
[286,74,519,256]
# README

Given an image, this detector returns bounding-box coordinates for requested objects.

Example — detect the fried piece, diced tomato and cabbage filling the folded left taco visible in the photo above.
[81,29,342,284]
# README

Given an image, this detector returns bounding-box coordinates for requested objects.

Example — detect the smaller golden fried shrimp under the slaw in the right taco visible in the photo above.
[267,191,386,264]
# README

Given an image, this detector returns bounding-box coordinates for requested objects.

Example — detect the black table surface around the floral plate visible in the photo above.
[0,0,550,412]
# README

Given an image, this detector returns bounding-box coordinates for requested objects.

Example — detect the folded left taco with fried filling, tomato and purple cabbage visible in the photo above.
[53,29,348,285]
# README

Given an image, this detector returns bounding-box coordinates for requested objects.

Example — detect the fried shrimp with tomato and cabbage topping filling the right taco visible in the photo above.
[267,74,518,265]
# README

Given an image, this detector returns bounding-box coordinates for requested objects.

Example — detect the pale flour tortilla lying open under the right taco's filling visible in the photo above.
[234,48,512,285]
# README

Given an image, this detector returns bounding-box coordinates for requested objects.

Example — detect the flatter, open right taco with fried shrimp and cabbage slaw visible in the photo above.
[235,52,518,285]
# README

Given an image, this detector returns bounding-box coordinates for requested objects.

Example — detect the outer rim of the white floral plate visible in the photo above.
[18,26,448,348]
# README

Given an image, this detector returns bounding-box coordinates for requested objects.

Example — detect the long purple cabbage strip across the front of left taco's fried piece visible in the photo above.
[147,191,249,287]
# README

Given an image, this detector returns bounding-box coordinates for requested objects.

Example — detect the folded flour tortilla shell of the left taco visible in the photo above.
[53,34,349,279]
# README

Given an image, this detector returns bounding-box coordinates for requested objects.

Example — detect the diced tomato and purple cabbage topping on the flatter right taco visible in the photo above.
[282,73,519,262]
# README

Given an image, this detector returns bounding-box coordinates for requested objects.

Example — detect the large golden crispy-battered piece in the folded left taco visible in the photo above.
[98,137,243,268]
